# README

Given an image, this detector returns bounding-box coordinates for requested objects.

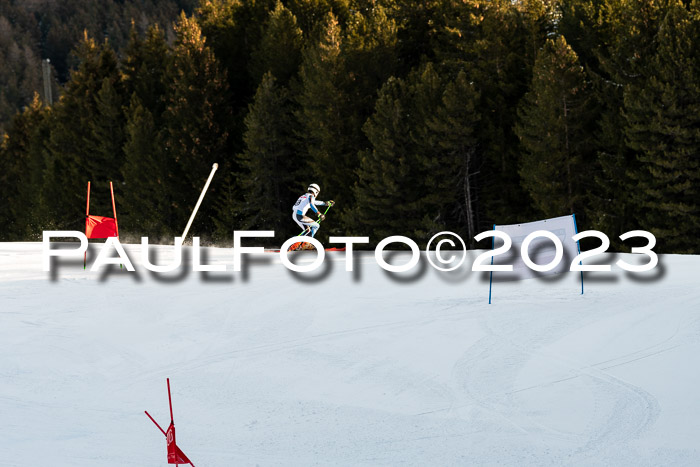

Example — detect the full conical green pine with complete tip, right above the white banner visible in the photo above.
[516,36,592,217]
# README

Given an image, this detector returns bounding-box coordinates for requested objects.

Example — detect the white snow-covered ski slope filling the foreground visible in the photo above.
[0,243,700,467]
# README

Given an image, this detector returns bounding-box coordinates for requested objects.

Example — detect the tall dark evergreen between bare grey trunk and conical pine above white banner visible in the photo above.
[476,0,549,229]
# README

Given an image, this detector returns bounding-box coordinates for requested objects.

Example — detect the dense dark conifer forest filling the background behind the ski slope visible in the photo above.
[0,0,700,254]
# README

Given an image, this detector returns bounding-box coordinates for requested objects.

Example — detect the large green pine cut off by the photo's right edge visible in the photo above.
[624,2,700,253]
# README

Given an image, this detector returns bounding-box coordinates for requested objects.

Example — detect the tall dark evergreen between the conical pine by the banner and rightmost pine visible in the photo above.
[588,0,668,241]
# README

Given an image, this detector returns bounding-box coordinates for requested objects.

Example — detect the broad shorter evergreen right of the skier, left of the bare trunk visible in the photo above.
[350,64,446,241]
